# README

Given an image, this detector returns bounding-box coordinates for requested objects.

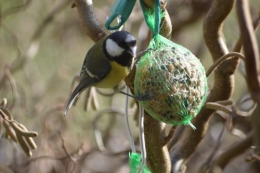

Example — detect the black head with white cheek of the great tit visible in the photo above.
[103,31,136,67]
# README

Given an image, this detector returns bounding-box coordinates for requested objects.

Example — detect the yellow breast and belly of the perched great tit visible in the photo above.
[94,62,129,88]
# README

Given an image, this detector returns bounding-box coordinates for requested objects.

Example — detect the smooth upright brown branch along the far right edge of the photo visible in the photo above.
[237,0,260,155]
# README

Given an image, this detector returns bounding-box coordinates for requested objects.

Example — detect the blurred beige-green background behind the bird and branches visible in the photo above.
[0,0,260,172]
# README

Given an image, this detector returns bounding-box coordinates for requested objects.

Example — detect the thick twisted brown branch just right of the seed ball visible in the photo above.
[171,0,239,170]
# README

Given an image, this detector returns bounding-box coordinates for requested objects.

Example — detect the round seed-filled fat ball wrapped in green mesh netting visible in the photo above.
[134,35,208,128]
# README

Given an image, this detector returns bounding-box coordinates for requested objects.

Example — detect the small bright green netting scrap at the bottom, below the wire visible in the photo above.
[129,153,151,173]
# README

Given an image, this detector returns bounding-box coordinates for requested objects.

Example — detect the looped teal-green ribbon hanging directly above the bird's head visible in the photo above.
[105,0,136,30]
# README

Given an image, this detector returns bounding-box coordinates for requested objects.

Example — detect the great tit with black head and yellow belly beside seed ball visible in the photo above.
[64,31,136,115]
